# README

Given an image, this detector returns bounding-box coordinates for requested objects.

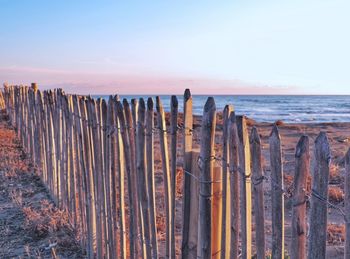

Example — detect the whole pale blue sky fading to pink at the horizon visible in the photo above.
[0,0,350,94]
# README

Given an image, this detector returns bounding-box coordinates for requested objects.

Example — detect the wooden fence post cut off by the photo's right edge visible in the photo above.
[344,148,350,259]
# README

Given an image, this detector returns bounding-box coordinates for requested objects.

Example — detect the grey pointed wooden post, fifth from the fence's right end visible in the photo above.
[250,127,265,259]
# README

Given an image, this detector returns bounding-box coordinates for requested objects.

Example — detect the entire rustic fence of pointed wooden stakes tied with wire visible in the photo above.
[0,84,350,259]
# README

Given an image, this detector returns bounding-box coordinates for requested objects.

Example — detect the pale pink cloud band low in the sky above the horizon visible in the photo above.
[0,67,298,94]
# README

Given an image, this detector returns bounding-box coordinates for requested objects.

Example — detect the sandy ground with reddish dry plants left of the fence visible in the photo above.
[0,112,83,258]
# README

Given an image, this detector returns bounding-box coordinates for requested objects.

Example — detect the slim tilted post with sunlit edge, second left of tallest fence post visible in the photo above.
[156,96,175,258]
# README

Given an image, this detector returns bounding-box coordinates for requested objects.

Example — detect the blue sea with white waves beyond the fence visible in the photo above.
[96,95,350,123]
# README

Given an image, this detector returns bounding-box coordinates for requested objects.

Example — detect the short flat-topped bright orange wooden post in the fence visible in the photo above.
[211,167,223,259]
